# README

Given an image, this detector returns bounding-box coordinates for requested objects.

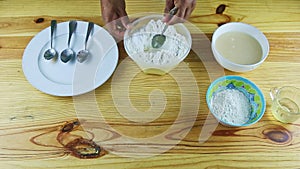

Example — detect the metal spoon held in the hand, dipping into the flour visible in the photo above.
[151,7,178,48]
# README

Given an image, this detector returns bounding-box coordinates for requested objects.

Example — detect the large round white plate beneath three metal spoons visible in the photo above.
[22,21,119,96]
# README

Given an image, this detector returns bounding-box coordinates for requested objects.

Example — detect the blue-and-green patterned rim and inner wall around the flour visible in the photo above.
[206,76,266,127]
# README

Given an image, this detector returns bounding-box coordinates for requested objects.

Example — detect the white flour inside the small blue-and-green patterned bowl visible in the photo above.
[211,89,251,124]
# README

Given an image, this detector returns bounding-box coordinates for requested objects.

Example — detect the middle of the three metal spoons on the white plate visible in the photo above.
[60,21,77,63]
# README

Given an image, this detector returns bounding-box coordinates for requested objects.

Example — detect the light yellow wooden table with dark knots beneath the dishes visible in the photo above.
[0,0,300,169]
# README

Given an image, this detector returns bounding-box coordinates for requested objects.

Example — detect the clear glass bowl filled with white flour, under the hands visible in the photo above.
[123,14,192,75]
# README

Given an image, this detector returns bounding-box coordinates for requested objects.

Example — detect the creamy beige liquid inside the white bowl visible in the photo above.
[216,32,262,65]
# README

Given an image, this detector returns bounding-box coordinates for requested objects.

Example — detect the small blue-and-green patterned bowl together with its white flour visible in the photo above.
[206,76,266,127]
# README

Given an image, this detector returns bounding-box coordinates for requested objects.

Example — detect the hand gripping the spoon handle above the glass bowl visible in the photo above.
[163,0,196,24]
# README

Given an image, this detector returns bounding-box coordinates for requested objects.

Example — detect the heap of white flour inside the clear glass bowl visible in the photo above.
[126,20,189,65]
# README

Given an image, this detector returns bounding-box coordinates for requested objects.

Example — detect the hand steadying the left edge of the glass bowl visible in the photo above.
[100,0,129,40]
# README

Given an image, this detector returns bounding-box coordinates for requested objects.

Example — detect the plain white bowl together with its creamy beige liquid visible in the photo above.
[211,22,269,72]
